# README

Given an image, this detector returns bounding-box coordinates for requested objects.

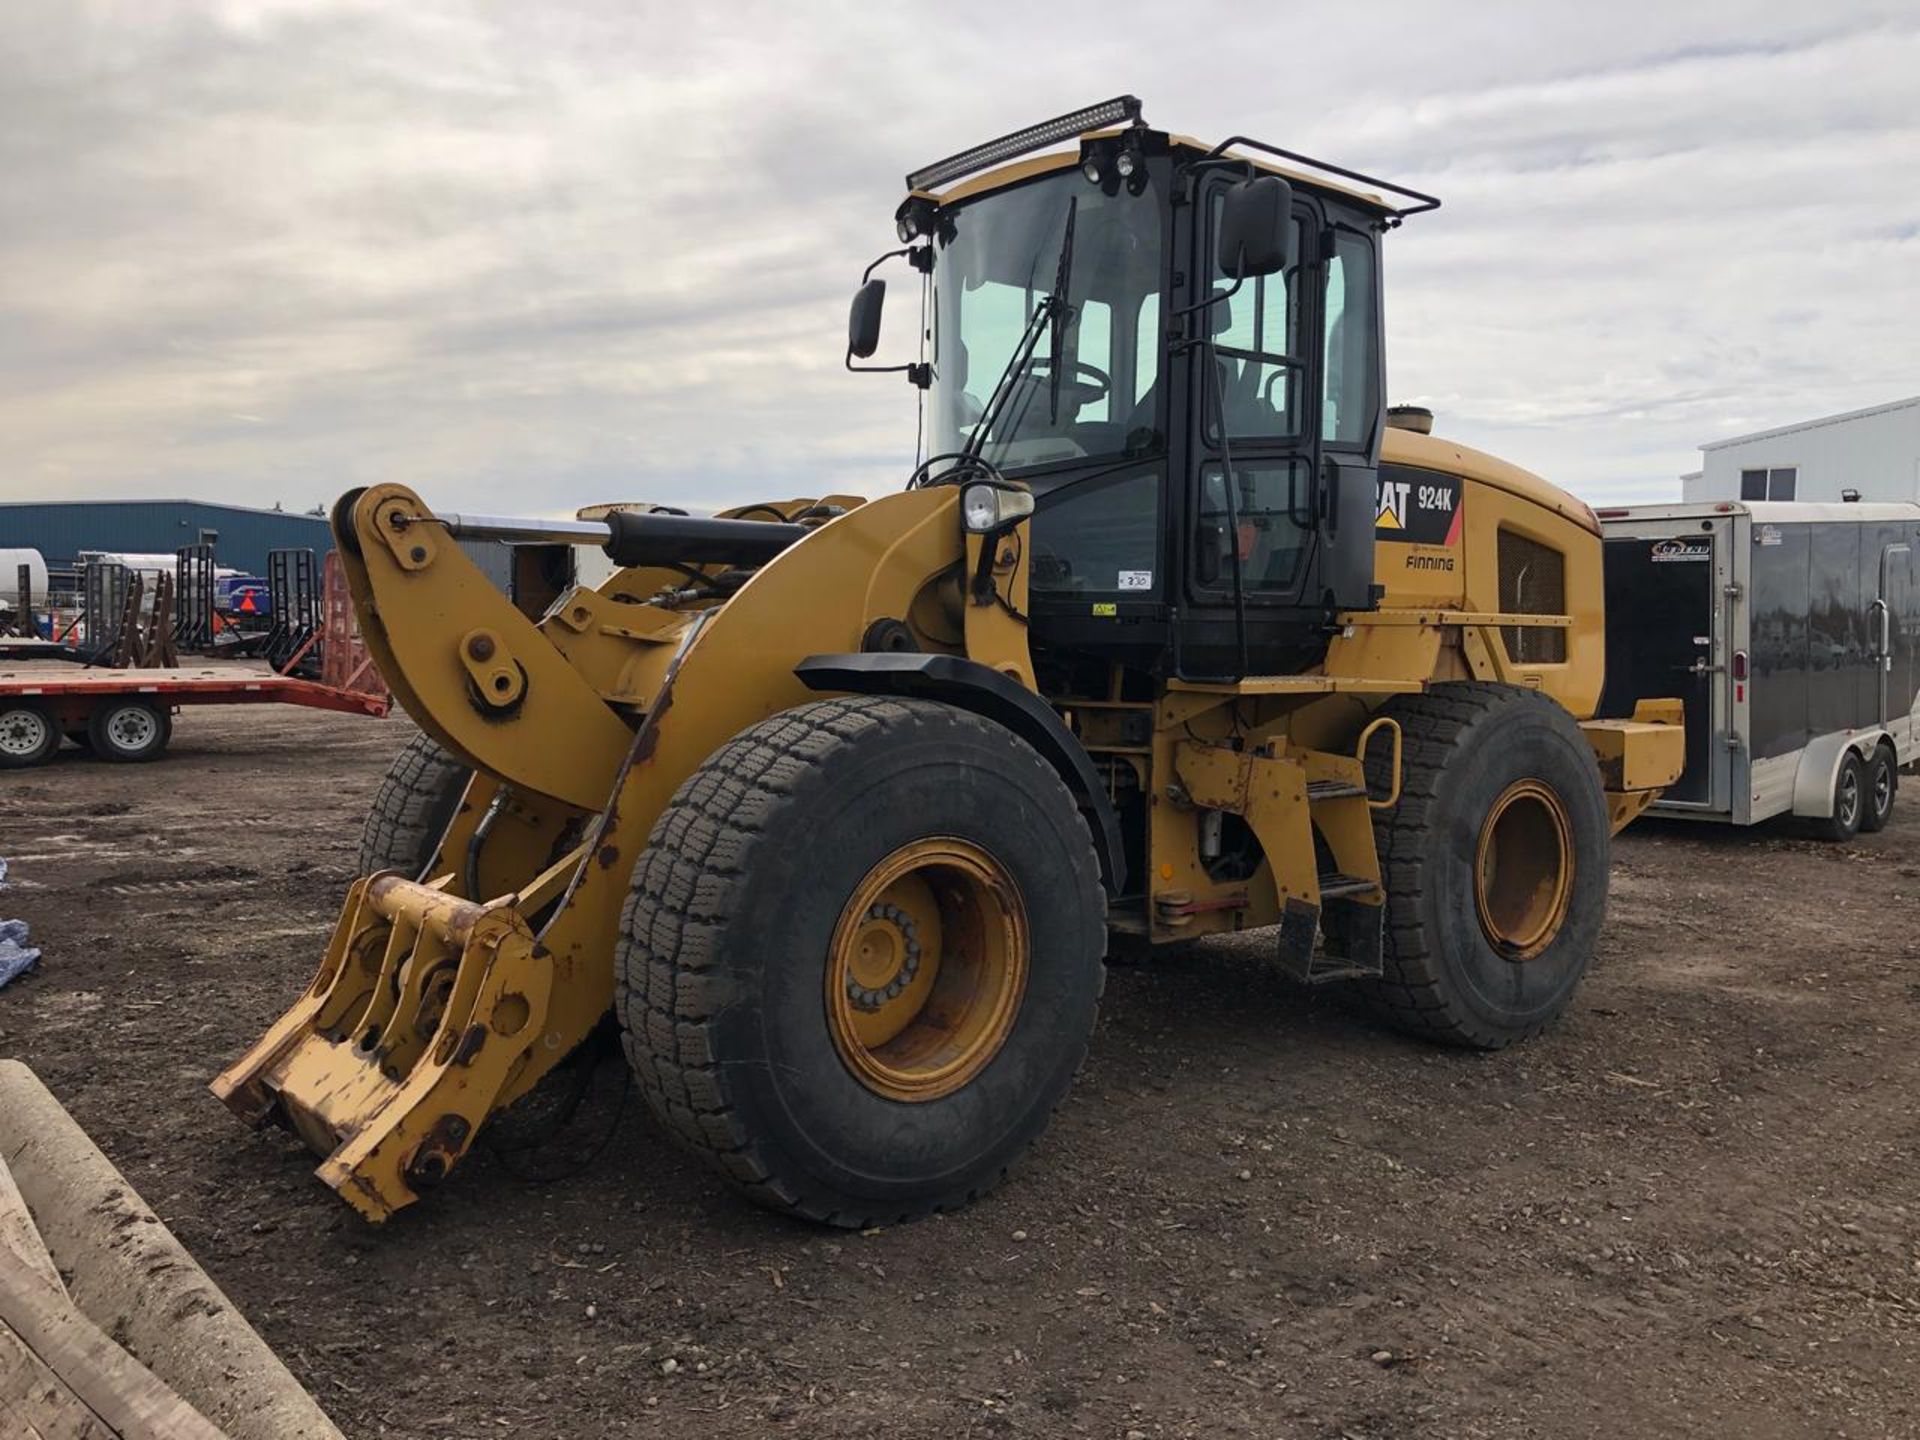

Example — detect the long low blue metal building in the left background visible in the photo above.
[0,499,334,574]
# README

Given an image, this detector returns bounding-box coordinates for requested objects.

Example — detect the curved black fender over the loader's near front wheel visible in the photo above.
[793,651,1127,895]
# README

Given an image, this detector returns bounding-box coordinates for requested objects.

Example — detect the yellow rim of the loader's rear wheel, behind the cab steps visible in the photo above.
[1473,780,1574,960]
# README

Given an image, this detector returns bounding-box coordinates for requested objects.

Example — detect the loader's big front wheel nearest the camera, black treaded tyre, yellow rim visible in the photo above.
[618,697,1106,1227]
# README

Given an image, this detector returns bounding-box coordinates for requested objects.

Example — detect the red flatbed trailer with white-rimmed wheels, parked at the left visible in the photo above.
[0,666,390,770]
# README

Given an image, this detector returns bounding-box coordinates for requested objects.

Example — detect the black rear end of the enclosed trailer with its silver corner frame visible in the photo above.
[1599,518,1732,810]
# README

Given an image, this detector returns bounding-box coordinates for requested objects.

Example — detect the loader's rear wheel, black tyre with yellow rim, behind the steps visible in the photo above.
[1357,684,1611,1050]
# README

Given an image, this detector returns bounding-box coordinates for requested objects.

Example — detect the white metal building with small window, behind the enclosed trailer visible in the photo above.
[1680,396,1920,503]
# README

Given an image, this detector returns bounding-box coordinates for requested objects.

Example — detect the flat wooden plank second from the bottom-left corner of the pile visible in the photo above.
[0,1250,227,1440]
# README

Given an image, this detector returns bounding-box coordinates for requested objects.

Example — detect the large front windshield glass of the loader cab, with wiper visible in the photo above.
[925,167,1164,470]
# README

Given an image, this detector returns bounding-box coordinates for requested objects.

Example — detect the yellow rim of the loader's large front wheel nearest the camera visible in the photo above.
[826,837,1029,1102]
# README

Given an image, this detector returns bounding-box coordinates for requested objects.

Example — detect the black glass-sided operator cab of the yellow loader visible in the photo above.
[871,109,1428,680]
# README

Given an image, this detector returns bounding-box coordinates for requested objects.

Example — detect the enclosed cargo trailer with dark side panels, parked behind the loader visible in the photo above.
[1599,501,1920,839]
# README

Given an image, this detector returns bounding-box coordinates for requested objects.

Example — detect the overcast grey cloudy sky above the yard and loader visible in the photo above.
[0,0,1920,513]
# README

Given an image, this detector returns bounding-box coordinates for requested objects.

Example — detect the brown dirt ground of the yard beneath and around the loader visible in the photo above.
[0,708,1920,1440]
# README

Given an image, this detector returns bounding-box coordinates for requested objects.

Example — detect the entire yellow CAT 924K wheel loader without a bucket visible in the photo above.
[213,98,1682,1225]
